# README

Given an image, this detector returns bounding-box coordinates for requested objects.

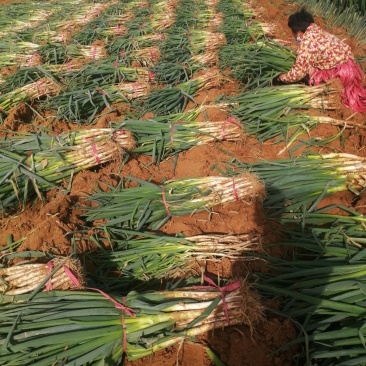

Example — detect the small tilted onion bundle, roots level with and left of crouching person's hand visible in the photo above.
[144,68,221,114]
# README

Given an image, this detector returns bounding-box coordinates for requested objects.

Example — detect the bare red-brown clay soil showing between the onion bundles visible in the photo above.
[0,0,366,366]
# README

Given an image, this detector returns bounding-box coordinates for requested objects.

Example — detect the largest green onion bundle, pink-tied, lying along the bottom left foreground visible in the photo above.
[0,281,262,366]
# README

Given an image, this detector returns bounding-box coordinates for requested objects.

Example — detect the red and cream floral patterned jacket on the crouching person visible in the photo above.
[279,23,353,83]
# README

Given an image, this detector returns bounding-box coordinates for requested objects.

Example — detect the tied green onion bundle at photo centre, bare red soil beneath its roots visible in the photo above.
[84,173,264,230]
